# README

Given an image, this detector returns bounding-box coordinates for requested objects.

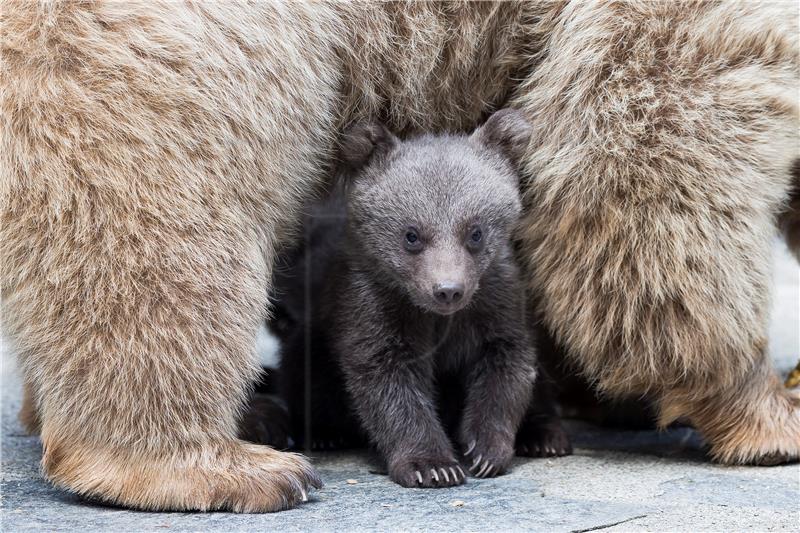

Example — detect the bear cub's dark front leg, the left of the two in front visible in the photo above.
[342,346,465,487]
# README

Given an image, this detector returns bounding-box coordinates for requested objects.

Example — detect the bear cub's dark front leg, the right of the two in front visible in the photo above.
[458,332,536,477]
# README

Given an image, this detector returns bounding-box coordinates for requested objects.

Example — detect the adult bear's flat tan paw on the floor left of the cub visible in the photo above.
[42,437,322,513]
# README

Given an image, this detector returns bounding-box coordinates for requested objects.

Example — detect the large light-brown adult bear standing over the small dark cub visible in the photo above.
[0,1,800,511]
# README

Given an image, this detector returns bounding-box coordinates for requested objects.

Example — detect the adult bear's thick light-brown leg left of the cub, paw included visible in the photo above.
[0,3,337,512]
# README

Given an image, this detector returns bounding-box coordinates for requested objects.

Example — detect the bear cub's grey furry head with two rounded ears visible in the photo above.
[342,109,531,315]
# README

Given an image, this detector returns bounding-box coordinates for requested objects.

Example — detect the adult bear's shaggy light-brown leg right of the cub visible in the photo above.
[515,3,800,463]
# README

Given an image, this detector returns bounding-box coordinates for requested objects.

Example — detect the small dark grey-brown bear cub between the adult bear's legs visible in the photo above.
[245,110,571,487]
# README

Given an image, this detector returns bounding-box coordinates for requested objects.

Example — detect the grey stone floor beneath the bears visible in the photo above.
[0,245,800,531]
